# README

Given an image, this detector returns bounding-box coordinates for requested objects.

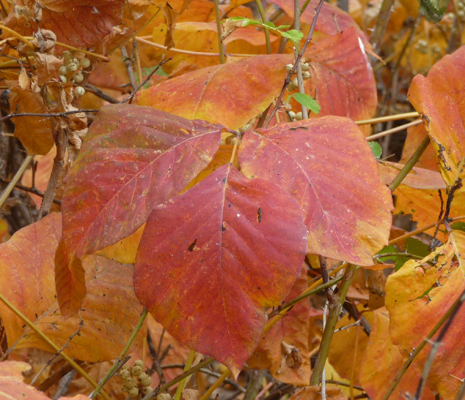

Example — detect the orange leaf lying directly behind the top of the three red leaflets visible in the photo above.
[137,55,292,130]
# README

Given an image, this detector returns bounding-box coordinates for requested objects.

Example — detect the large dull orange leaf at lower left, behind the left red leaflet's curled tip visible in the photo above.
[0,213,143,365]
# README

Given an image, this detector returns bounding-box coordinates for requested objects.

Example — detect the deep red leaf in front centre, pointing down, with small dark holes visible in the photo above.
[134,164,307,376]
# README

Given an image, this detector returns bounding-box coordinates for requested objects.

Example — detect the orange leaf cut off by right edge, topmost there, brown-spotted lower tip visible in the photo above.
[408,47,465,193]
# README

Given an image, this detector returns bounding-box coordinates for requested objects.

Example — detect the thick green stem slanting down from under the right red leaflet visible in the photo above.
[310,264,357,386]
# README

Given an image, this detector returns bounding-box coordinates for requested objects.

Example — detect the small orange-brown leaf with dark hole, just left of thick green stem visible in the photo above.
[248,266,311,386]
